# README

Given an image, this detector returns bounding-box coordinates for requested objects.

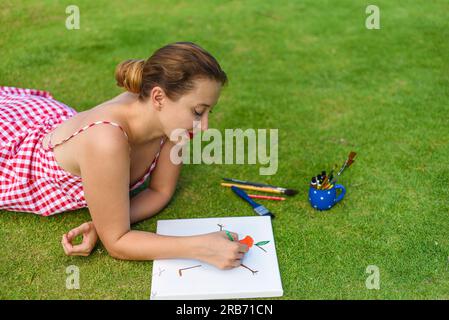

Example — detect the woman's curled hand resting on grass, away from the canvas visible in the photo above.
[61,221,98,257]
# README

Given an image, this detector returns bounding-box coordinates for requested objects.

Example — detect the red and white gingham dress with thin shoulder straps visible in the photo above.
[0,86,164,216]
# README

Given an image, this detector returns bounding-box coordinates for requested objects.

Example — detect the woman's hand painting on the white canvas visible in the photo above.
[192,231,248,270]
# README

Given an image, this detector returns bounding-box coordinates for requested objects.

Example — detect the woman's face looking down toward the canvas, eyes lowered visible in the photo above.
[159,79,222,138]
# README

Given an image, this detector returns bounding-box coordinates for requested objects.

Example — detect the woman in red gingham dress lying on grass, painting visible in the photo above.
[0,42,248,269]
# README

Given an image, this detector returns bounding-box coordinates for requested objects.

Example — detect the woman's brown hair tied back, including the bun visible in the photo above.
[115,42,228,101]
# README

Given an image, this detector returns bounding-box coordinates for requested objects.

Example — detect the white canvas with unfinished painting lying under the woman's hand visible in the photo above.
[150,216,283,300]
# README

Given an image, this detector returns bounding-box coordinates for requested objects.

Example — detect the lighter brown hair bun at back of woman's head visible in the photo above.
[115,59,145,94]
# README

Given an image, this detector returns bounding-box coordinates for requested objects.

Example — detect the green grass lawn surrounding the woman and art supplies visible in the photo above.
[0,0,449,299]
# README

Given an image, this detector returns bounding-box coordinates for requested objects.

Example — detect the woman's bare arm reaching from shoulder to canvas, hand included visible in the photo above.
[75,126,247,269]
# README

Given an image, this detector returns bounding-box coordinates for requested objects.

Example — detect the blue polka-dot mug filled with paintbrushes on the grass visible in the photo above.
[309,151,356,211]
